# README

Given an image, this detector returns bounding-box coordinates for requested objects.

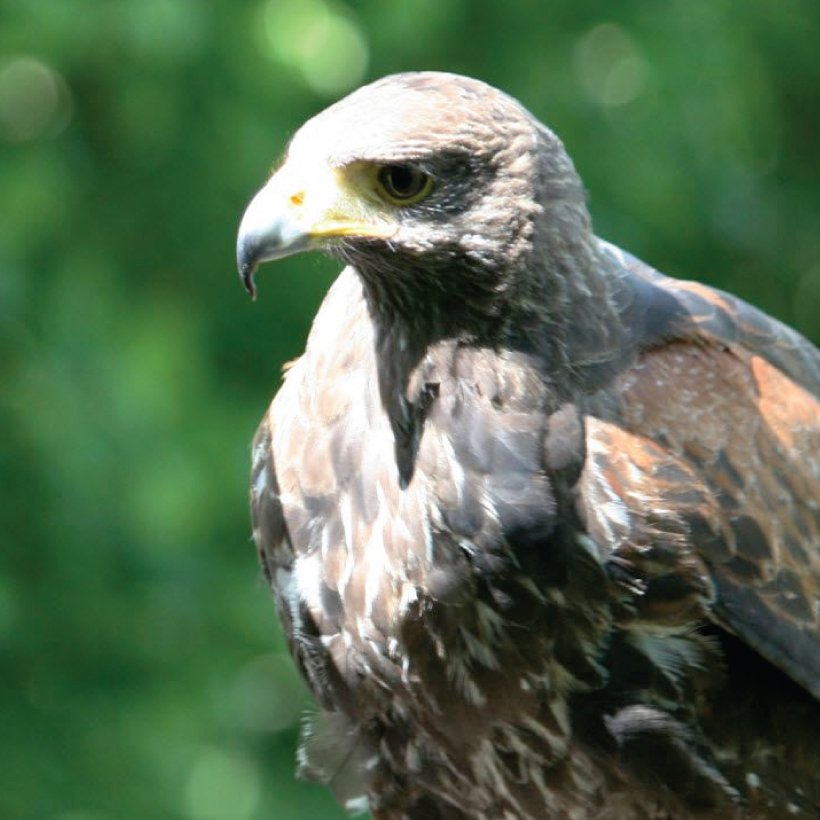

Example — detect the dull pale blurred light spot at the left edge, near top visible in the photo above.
[0,56,73,142]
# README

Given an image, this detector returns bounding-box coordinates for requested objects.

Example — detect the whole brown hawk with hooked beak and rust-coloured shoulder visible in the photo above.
[237,72,820,820]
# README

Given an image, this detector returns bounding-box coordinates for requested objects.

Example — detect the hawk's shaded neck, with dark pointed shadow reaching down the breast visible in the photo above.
[346,243,633,486]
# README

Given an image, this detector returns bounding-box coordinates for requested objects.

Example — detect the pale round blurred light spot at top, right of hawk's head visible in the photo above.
[573,23,649,108]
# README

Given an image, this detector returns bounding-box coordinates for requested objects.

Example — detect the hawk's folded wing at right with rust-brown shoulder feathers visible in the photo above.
[581,248,820,699]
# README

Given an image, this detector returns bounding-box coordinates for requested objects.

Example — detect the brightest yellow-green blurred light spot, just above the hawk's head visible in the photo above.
[265,0,370,96]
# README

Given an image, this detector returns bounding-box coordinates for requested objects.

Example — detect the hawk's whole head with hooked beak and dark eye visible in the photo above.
[237,72,589,310]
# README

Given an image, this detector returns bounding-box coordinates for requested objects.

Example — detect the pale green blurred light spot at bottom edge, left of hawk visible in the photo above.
[185,748,262,820]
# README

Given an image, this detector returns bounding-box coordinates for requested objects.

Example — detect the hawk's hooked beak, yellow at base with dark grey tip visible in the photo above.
[236,160,395,299]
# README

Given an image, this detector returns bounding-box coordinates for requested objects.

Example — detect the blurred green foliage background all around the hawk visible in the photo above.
[0,0,820,820]
